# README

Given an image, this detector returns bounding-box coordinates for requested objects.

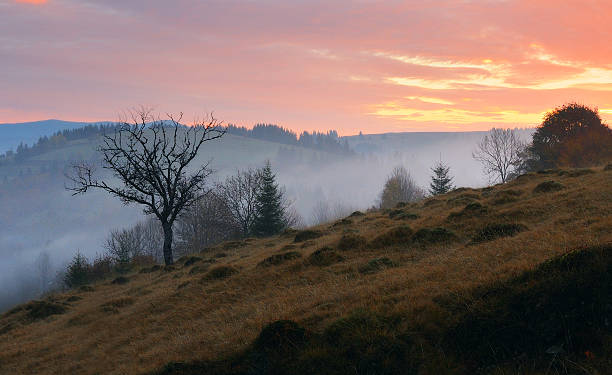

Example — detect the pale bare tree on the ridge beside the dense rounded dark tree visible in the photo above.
[472,128,525,183]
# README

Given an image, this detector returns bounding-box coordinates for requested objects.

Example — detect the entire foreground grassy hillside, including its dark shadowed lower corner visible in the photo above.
[0,167,612,374]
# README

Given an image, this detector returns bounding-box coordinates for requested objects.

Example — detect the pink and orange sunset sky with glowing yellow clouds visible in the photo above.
[0,0,612,135]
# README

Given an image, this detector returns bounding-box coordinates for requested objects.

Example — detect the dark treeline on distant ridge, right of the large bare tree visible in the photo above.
[227,124,353,155]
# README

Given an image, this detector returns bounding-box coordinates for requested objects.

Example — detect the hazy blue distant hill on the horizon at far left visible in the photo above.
[0,120,93,154]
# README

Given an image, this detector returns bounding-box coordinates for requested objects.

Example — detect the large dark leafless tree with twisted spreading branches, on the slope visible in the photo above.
[68,109,225,265]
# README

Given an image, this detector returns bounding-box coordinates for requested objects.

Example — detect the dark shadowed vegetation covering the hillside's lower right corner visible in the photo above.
[157,245,612,374]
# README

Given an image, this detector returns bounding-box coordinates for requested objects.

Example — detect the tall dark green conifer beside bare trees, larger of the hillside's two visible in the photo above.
[251,161,287,237]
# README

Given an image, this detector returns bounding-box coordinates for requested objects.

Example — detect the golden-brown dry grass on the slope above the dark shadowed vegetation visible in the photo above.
[0,168,612,374]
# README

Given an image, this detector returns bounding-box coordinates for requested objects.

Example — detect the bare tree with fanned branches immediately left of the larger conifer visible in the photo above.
[218,169,262,237]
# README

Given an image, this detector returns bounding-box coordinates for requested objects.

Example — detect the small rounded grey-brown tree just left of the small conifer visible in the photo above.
[380,166,425,208]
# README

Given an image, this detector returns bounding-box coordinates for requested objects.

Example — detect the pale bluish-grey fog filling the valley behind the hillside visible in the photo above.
[0,130,531,311]
